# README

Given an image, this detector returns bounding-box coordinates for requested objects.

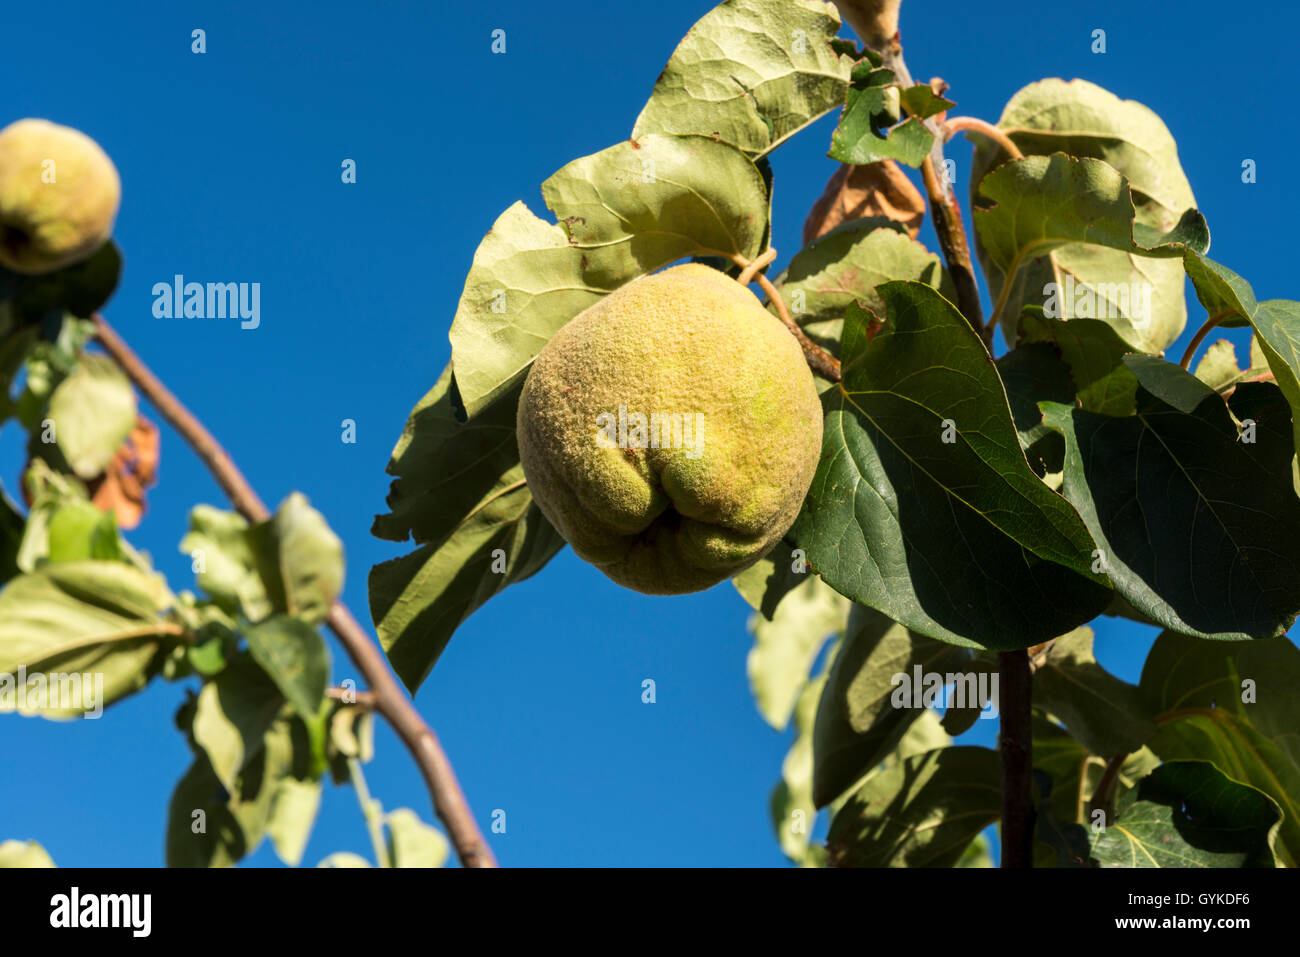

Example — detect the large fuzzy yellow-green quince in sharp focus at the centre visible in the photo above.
[517,264,822,594]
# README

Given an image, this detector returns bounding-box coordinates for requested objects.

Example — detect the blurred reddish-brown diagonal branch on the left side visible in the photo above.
[91,313,497,867]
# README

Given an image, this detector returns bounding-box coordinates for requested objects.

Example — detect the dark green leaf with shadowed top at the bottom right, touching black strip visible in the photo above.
[1092,761,1282,867]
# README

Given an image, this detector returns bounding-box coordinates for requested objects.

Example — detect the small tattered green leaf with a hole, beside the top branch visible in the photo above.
[829,59,935,166]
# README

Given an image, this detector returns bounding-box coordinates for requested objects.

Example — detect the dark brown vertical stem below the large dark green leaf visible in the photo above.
[997,651,1036,867]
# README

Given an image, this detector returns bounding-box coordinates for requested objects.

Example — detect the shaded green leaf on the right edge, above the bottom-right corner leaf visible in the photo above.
[1140,632,1300,867]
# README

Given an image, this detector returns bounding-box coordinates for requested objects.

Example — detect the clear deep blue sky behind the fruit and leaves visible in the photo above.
[0,0,1300,866]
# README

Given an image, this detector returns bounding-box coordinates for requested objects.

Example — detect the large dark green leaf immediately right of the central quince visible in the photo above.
[794,282,1110,650]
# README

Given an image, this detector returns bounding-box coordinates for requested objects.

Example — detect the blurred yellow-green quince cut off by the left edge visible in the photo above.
[0,120,122,274]
